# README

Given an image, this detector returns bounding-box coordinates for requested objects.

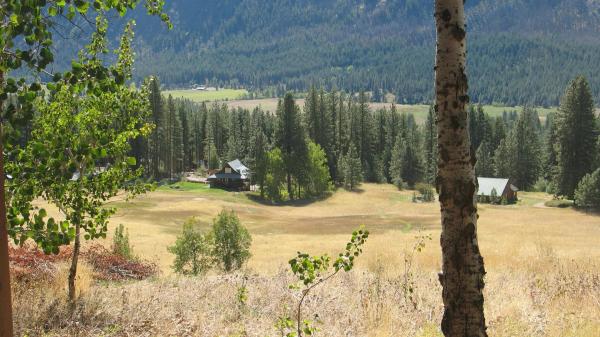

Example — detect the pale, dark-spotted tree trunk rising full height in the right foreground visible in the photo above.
[435,0,487,337]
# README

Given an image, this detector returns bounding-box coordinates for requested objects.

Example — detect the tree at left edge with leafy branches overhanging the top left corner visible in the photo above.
[0,0,170,330]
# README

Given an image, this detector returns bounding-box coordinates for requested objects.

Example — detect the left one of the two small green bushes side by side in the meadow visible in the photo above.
[167,218,213,276]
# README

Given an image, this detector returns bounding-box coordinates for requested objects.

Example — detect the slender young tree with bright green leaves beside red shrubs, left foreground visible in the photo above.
[9,21,150,301]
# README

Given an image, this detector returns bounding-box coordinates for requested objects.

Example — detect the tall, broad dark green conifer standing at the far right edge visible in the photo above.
[556,76,597,198]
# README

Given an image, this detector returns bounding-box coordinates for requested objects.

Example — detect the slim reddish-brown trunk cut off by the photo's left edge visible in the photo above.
[0,71,13,337]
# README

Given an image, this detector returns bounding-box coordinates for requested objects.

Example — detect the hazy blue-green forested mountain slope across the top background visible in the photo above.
[111,0,600,105]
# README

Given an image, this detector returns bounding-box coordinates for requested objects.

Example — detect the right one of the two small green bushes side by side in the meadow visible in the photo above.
[211,211,252,272]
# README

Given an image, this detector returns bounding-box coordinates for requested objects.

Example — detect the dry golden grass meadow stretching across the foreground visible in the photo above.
[9,184,600,337]
